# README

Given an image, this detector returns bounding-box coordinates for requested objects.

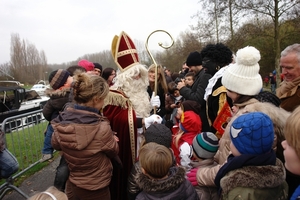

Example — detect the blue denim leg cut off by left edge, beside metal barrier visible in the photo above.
[0,148,19,178]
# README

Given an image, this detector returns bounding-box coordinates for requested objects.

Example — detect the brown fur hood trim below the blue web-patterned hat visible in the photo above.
[220,159,286,194]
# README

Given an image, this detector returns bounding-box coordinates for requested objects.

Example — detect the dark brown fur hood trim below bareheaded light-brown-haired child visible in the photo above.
[137,167,186,192]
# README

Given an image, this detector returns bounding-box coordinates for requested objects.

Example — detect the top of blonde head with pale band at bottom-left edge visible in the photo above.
[28,186,68,200]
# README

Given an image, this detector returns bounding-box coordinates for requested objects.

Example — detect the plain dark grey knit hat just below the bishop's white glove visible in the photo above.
[144,124,172,148]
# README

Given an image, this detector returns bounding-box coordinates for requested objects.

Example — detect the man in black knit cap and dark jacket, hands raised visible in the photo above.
[177,51,211,131]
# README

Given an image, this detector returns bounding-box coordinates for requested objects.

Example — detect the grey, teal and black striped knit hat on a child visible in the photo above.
[192,132,219,159]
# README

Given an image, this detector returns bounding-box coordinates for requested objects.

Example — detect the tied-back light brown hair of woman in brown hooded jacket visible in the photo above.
[73,73,109,104]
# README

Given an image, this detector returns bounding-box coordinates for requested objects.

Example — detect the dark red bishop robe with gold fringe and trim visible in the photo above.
[103,90,137,200]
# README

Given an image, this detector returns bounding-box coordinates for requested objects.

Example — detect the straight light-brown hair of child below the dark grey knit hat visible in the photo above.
[139,142,173,179]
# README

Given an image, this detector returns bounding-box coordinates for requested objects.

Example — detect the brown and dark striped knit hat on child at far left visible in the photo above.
[49,69,70,90]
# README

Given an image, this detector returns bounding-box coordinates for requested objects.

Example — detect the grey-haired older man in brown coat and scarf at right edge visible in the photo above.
[276,44,300,111]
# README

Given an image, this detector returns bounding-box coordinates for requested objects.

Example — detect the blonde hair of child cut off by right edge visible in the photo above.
[284,106,300,158]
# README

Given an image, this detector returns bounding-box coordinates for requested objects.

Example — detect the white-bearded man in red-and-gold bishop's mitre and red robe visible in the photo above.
[103,32,162,200]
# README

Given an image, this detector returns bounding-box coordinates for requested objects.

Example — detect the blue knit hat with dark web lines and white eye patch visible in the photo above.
[230,112,274,155]
